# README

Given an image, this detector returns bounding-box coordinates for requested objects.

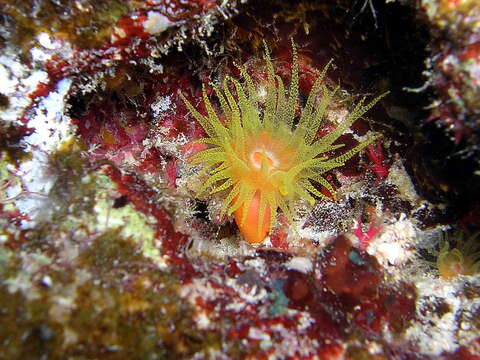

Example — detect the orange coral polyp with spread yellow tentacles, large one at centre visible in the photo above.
[180,42,385,243]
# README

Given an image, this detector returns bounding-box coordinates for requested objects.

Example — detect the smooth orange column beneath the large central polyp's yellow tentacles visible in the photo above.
[234,191,271,244]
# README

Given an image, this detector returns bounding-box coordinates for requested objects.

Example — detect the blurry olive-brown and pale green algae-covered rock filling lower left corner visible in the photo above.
[0,140,225,359]
